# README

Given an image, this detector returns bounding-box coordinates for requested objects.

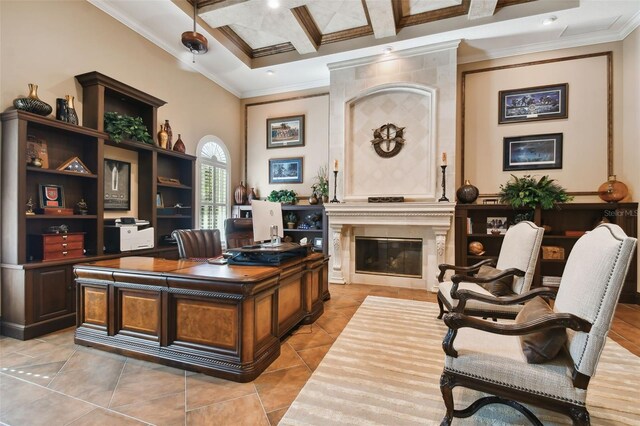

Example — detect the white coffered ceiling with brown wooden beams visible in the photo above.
[87,0,640,98]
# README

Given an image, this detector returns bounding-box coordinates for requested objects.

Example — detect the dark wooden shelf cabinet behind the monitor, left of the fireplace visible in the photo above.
[231,204,329,256]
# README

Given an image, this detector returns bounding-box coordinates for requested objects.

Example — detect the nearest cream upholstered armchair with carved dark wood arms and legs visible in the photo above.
[440,224,637,425]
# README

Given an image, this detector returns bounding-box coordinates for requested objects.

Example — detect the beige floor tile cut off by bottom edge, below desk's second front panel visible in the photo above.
[111,388,185,426]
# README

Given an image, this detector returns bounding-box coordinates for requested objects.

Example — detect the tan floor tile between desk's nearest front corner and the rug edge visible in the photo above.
[254,366,311,413]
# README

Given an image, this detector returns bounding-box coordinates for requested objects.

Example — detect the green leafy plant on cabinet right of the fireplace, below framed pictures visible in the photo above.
[499,175,573,210]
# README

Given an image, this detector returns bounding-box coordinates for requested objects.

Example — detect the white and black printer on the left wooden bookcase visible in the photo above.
[104,217,154,253]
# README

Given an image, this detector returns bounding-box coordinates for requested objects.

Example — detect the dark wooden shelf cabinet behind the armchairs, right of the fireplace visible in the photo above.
[455,203,638,303]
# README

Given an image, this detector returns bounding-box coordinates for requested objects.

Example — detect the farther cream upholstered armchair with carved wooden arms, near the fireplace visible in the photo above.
[438,221,544,318]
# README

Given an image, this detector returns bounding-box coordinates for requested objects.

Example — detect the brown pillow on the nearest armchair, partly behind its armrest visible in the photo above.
[516,296,567,364]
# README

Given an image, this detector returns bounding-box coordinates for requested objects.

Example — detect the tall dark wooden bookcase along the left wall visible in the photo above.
[0,72,195,339]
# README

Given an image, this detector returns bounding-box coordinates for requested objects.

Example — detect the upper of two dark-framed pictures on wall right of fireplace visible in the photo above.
[498,83,568,124]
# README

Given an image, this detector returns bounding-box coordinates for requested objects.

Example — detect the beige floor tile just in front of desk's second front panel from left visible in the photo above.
[109,364,185,411]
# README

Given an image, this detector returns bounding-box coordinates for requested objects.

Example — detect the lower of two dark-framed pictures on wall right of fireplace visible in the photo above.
[502,133,562,171]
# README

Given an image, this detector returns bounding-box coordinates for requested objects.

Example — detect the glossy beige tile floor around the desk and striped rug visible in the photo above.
[0,284,640,426]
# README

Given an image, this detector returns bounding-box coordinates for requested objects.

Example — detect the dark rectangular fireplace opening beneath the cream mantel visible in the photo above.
[355,237,422,278]
